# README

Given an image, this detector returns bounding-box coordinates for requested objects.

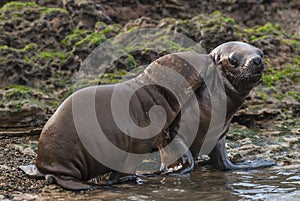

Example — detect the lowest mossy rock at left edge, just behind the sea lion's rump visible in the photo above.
[0,85,58,128]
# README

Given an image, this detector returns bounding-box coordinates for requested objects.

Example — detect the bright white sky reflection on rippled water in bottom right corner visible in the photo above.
[230,167,300,200]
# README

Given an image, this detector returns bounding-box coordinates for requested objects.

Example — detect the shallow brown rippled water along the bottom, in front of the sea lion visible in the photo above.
[86,167,300,201]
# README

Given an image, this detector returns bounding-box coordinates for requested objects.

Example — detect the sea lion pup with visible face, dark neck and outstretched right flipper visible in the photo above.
[165,41,276,173]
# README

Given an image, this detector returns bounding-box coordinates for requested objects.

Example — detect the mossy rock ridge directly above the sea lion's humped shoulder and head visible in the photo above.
[124,11,243,52]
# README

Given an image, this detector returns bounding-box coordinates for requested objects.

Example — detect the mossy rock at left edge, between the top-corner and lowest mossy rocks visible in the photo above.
[0,43,79,90]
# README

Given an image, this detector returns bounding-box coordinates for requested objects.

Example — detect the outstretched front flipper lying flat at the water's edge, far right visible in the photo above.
[209,136,276,170]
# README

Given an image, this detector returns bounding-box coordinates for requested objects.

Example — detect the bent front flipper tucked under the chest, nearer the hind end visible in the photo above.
[159,136,194,174]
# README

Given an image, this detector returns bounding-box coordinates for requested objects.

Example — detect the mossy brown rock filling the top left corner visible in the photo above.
[0,2,74,49]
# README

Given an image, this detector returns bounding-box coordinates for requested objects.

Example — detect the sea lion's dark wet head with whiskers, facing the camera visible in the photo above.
[209,41,264,94]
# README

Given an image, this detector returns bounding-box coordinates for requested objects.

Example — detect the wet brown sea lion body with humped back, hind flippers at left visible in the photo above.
[20,52,213,190]
